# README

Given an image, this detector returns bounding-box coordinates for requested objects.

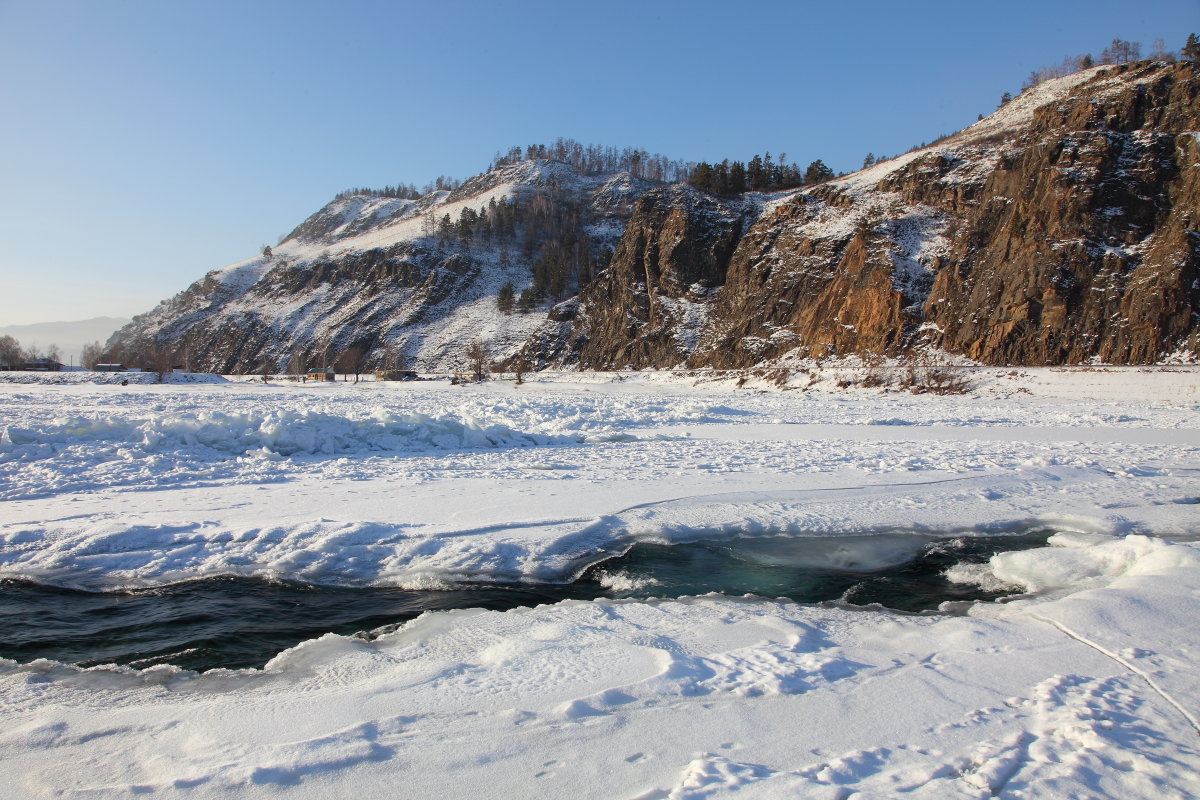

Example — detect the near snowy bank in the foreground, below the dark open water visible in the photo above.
[0,536,1200,800]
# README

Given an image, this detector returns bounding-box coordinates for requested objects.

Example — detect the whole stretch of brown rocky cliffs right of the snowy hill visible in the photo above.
[527,62,1200,368]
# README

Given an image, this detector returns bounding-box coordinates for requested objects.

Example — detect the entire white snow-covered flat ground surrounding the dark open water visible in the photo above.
[0,368,1200,800]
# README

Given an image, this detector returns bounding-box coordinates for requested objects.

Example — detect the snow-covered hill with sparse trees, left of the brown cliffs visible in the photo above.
[108,160,654,372]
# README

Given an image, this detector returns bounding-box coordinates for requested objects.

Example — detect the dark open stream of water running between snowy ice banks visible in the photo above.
[0,531,1051,669]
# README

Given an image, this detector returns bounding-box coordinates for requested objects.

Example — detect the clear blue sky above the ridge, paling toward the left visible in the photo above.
[0,0,1200,325]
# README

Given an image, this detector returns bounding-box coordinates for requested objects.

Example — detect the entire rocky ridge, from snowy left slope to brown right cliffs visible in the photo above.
[108,61,1200,372]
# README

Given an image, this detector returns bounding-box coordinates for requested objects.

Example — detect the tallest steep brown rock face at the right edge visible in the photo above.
[925,64,1200,363]
